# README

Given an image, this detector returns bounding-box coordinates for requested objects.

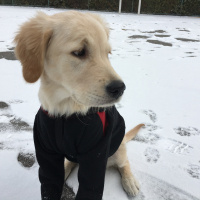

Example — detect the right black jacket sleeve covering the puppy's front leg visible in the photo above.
[76,116,111,200]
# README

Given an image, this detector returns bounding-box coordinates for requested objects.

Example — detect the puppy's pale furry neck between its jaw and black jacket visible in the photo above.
[39,76,90,116]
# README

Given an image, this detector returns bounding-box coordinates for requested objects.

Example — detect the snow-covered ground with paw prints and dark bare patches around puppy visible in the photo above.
[0,7,200,200]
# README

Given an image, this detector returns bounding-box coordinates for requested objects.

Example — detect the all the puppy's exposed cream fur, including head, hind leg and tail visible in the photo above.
[14,11,143,196]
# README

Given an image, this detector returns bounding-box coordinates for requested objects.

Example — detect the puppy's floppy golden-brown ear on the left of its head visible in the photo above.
[14,12,53,83]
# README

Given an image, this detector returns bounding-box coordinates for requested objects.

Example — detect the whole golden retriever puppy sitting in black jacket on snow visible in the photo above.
[14,11,143,200]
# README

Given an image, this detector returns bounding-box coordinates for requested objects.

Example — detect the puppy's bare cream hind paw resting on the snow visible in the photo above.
[122,177,140,196]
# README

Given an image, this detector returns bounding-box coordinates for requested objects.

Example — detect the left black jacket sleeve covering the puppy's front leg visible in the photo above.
[34,115,64,200]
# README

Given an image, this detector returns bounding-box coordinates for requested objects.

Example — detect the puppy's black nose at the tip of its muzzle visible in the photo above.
[106,81,126,99]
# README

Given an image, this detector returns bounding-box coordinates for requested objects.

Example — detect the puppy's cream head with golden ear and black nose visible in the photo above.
[15,11,125,107]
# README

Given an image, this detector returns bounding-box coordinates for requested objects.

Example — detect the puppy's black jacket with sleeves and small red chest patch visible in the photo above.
[34,106,125,200]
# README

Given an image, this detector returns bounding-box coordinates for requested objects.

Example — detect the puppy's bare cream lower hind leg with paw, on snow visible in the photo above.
[118,160,139,196]
